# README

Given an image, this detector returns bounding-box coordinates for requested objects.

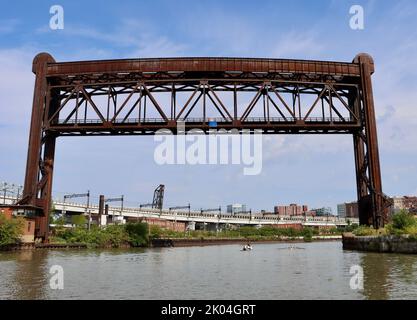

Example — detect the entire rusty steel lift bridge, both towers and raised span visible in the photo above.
[13,53,390,241]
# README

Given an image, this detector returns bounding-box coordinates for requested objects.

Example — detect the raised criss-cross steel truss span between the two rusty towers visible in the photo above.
[44,59,362,135]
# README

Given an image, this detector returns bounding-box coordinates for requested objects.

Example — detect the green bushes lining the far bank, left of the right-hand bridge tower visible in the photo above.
[0,215,362,248]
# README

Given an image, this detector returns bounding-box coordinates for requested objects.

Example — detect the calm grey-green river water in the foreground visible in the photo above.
[0,242,417,300]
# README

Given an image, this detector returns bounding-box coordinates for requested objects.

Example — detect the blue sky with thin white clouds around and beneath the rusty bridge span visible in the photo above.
[0,0,417,210]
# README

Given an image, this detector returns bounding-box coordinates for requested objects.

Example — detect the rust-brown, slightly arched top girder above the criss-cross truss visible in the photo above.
[44,58,360,76]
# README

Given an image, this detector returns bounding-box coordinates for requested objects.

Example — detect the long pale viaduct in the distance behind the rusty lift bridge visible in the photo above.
[1,197,359,227]
